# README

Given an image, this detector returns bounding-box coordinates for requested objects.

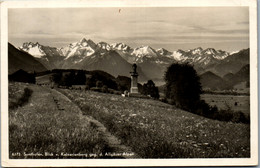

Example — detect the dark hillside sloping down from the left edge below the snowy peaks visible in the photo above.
[8,43,47,74]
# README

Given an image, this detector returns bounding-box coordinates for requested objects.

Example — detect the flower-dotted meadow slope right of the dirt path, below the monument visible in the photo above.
[59,89,250,158]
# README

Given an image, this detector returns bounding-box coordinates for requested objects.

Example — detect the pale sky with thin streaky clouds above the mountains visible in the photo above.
[8,7,249,52]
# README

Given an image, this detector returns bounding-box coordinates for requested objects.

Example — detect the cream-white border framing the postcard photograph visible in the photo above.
[0,0,258,167]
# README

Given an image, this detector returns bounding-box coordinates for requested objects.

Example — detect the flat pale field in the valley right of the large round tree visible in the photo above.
[201,94,250,115]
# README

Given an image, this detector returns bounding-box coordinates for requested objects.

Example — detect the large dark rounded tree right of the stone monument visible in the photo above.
[164,63,202,111]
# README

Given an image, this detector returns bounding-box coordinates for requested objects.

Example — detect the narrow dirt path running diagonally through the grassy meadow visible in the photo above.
[49,89,138,158]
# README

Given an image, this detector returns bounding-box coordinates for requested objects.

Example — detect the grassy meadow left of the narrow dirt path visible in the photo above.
[9,83,113,159]
